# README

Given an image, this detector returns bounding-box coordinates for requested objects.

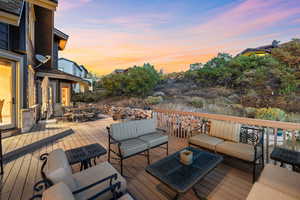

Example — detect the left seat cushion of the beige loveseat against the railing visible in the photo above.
[189,134,224,151]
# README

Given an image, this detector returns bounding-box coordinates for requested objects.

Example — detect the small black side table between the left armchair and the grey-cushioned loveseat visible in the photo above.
[66,143,107,170]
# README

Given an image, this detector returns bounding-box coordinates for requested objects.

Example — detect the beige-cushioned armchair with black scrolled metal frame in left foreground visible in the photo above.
[34,149,126,200]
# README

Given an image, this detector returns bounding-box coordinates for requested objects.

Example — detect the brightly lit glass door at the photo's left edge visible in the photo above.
[0,59,16,129]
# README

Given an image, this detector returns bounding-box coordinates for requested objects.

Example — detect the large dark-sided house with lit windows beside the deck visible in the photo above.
[0,0,84,131]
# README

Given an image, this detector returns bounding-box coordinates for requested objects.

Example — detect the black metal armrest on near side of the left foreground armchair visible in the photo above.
[73,173,121,199]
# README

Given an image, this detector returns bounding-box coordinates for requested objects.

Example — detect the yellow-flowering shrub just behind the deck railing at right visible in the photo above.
[255,108,287,121]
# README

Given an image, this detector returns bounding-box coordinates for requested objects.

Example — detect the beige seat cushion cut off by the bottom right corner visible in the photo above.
[247,164,300,200]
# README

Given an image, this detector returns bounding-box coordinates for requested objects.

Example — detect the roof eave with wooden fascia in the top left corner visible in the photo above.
[0,0,24,26]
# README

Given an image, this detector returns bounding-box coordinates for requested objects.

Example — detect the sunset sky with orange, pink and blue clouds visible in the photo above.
[55,0,300,74]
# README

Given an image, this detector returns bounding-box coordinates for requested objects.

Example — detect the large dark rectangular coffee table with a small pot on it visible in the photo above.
[146,147,223,199]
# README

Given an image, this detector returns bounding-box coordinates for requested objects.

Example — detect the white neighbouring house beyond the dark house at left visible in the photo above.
[58,58,93,93]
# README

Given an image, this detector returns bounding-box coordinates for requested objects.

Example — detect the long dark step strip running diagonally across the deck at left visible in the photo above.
[3,129,74,164]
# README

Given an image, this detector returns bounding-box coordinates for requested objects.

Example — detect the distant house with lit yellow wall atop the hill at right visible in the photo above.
[237,40,279,56]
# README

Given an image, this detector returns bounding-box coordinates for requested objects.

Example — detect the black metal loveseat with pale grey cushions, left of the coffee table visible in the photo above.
[107,118,168,175]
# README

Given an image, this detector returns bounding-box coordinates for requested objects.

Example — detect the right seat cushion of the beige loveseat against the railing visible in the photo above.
[216,141,254,161]
